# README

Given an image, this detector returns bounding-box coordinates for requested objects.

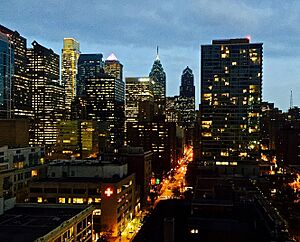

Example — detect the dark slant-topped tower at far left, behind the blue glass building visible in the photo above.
[0,25,33,118]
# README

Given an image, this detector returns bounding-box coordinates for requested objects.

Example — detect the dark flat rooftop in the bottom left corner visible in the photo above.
[0,204,86,242]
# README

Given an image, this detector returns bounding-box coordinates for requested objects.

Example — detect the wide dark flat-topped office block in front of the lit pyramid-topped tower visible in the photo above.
[85,73,125,148]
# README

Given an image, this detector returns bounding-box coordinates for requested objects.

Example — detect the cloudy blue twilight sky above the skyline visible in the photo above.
[0,0,300,110]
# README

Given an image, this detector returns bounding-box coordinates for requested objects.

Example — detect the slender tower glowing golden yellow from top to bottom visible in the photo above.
[61,38,80,113]
